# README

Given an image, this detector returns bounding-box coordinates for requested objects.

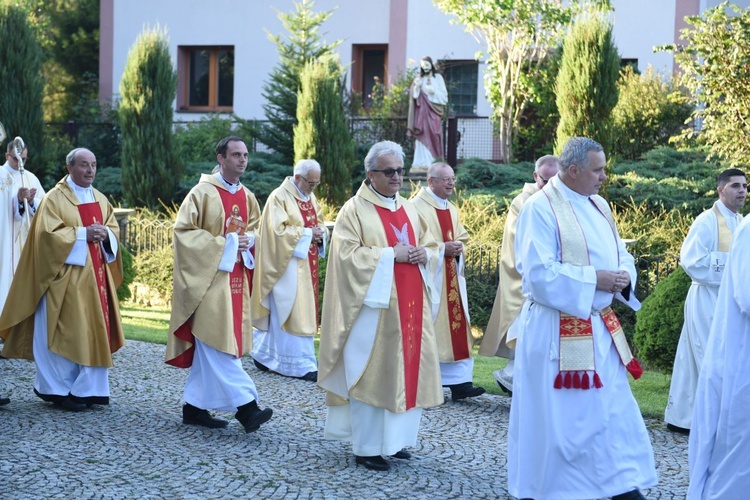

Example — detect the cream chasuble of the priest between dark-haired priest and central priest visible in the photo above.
[252,177,324,337]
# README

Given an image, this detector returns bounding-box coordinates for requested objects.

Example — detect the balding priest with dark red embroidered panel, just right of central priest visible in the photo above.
[411,163,485,401]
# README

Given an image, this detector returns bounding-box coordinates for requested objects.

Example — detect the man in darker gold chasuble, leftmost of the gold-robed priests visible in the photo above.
[0,148,125,411]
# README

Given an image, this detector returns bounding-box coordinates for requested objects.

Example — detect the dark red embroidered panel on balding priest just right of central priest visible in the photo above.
[435,208,469,361]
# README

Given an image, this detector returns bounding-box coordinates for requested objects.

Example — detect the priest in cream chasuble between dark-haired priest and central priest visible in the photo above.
[251,160,328,382]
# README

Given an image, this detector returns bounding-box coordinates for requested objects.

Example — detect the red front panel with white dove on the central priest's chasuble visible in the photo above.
[375,206,424,410]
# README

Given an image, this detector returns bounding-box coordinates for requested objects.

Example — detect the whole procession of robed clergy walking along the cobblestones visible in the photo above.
[0,136,750,499]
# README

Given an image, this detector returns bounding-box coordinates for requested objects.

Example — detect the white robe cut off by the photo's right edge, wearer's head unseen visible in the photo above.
[688,217,750,500]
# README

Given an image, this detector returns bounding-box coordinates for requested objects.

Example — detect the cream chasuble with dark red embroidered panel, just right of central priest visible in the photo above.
[411,188,474,363]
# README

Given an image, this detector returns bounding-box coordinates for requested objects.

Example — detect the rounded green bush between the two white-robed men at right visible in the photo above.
[633,267,691,372]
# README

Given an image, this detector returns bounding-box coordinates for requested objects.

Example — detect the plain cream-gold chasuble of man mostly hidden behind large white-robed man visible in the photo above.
[479,182,539,358]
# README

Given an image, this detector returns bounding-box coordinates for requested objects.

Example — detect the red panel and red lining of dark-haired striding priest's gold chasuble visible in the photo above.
[168,187,255,368]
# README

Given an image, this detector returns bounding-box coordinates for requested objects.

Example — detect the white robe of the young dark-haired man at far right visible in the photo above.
[664,201,742,429]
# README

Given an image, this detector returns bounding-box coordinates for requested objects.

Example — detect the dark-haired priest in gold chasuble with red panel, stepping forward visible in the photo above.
[166,136,272,432]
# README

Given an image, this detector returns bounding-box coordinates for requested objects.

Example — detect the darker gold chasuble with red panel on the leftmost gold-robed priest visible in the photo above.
[0,176,125,367]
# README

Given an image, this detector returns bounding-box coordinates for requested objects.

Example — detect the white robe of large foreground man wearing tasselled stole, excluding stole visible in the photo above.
[508,177,657,500]
